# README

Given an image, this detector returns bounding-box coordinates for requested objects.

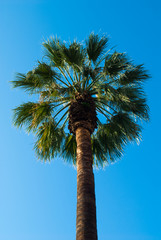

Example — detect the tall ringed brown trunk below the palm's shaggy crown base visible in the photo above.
[76,127,97,240]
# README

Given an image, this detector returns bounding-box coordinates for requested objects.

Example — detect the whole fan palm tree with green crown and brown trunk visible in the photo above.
[12,33,149,240]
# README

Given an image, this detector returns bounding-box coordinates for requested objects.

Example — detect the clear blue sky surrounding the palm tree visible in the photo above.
[0,0,161,240]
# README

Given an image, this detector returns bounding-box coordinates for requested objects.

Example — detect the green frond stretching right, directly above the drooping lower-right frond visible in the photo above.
[95,83,149,120]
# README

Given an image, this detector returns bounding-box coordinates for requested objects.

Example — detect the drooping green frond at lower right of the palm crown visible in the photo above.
[96,112,141,161]
